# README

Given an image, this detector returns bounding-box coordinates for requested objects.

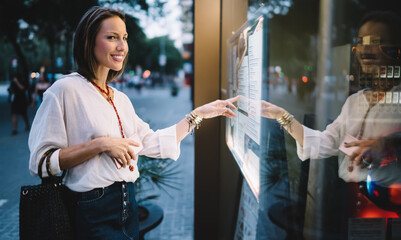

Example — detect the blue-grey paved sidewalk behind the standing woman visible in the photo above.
[0,84,194,240]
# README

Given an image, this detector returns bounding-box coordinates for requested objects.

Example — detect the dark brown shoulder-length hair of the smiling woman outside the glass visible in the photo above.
[73,6,128,81]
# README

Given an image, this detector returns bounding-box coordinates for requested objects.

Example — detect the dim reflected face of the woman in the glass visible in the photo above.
[356,22,392,73]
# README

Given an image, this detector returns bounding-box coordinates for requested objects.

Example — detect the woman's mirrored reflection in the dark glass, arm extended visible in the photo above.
[262,12,401,218]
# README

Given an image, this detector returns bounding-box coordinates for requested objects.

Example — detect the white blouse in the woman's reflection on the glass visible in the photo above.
[297,90,401,182]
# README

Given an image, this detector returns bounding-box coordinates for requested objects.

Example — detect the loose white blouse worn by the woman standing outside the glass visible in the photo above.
[28,73,180,192]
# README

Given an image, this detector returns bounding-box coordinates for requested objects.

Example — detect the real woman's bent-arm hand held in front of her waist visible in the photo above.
[101,137,140,168]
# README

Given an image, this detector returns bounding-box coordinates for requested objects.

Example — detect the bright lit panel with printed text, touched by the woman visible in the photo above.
[226,16,267,198]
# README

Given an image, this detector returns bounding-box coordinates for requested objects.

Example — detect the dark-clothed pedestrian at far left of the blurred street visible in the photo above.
[8,74,30,135]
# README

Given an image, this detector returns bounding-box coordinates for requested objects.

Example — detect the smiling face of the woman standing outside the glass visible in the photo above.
[94,17,128,72]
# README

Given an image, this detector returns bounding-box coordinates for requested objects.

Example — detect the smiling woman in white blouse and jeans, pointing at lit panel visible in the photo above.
[29,7,237,239]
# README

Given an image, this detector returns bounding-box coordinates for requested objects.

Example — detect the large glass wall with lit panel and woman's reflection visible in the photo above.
[226,0,401,239]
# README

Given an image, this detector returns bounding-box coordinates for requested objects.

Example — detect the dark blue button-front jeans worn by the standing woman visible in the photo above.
[75,182,139,240]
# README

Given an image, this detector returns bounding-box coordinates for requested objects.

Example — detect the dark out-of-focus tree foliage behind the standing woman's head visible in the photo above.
[0,0,182,80]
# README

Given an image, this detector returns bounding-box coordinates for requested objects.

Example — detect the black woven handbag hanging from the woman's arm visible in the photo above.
[19,149,74,240]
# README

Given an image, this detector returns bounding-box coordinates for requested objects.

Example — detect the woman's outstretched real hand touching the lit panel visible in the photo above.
[194,96,240,119]
